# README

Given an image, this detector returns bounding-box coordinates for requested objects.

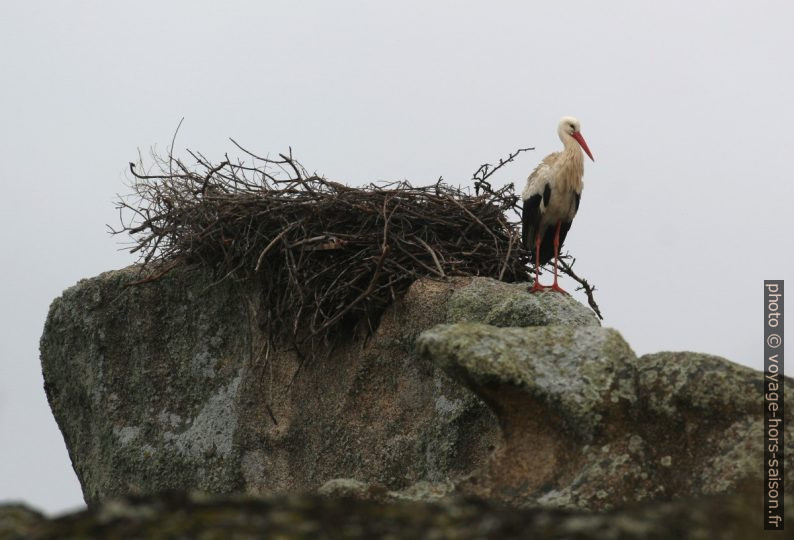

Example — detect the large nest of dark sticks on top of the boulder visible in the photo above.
[113,143,529,352]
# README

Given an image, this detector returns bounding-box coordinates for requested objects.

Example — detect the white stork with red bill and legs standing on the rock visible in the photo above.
[521,116,595,294]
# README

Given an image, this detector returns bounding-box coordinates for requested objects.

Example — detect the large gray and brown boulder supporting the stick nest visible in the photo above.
[41,267,593,502]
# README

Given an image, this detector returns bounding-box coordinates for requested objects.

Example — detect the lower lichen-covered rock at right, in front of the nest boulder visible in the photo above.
[417,324,794,509]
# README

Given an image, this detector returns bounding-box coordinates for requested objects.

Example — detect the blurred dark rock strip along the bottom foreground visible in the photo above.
[0,492,780,540]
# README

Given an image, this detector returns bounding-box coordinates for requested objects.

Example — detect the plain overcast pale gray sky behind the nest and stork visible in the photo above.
[0,0,794,512]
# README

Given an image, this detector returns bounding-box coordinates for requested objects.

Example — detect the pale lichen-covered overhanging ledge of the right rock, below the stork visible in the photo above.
[417,322,637,437]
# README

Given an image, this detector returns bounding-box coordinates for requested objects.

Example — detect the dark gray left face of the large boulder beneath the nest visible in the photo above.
[41,268,250,502]
